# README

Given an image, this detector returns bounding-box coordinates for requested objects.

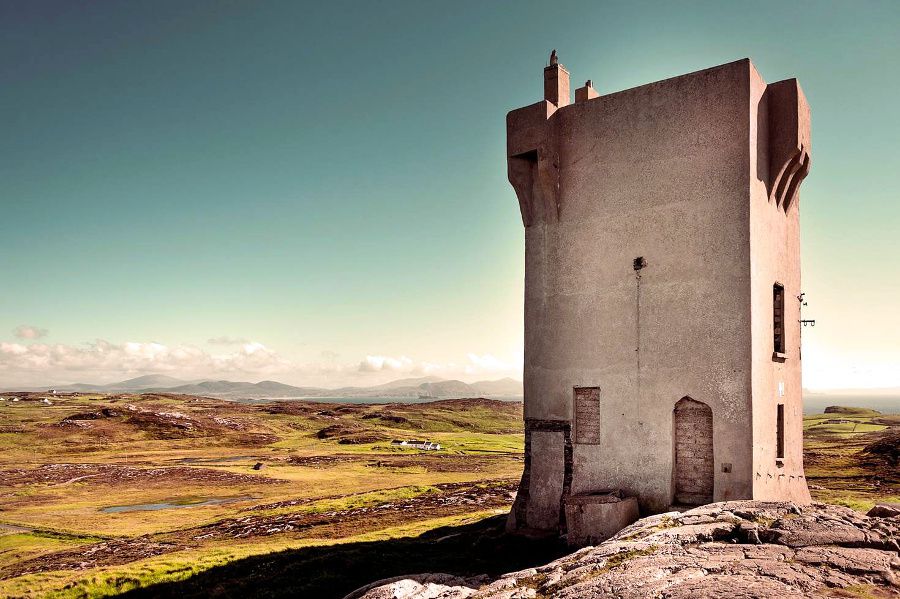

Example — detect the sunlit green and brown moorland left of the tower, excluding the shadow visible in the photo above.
[0,394,524,597]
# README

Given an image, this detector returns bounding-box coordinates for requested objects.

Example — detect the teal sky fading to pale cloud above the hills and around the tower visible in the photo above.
[0,0,900,389]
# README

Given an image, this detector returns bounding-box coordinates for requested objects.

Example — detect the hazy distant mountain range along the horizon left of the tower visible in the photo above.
[45,374,522,399]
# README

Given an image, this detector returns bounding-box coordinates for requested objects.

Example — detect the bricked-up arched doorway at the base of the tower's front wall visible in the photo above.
[673,397,714,505]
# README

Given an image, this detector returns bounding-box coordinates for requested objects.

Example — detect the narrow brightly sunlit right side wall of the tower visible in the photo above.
[750,68,810,503]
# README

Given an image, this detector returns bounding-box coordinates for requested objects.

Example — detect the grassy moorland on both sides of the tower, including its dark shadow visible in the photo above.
[0,394,900,597]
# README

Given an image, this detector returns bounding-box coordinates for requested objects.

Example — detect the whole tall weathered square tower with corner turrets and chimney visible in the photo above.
[506,53,810,531]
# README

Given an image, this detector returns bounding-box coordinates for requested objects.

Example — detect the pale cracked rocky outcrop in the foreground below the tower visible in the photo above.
[348,501,900,599]
